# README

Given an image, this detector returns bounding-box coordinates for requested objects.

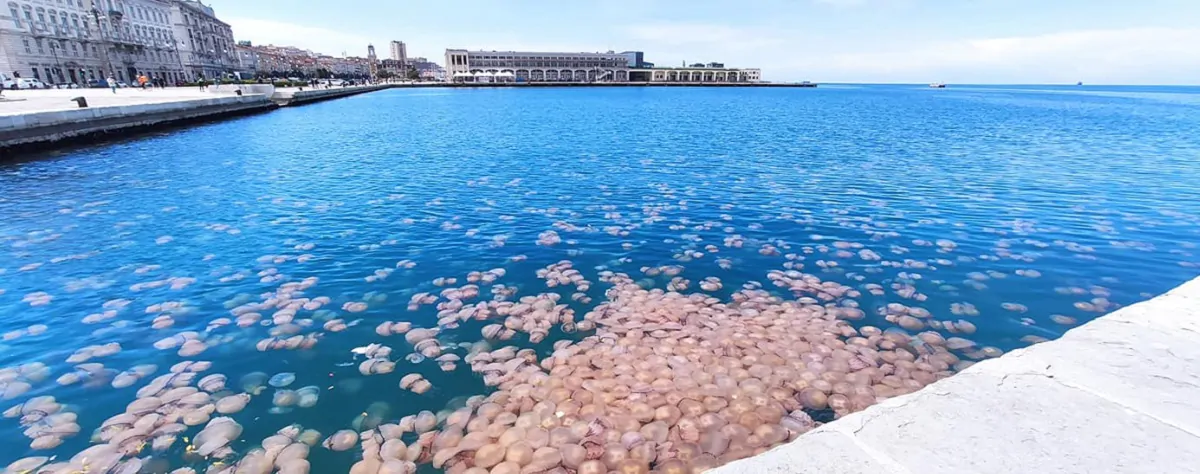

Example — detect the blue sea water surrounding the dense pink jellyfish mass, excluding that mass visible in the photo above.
[0,85,1200,472]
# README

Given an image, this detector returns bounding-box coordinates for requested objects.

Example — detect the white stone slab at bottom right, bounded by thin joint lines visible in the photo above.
[836,372,1200,474]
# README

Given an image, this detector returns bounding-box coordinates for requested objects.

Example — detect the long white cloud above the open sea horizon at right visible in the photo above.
[792,28,1200,84]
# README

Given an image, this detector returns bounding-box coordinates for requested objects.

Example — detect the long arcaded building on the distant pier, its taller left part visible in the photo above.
[445,49,629,82]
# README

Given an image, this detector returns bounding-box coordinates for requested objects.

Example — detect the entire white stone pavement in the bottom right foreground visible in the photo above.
[715,278,1200,474]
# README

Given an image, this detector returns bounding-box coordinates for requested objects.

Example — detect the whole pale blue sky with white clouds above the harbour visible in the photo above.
[204,0,1200,84]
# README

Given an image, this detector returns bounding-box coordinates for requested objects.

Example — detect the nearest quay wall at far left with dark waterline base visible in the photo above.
[0,95,275,156]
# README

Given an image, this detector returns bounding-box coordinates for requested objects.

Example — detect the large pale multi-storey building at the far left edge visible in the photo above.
[0,0,184,84]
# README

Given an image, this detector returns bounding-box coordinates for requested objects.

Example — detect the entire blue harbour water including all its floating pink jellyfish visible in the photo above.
[0,86,1200,473]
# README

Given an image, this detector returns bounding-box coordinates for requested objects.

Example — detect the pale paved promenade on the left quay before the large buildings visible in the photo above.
[0,86,247,115]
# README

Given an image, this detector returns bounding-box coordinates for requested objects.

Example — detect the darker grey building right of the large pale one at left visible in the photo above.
[169,0,239,80]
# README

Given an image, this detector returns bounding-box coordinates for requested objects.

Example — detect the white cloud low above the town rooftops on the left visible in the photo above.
[224,17,372,56]
